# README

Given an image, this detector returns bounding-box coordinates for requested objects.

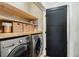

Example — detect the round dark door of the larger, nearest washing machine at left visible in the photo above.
[8,44,29,57]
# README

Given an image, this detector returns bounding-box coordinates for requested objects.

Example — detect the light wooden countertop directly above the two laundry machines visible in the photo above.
[0,32,42,40]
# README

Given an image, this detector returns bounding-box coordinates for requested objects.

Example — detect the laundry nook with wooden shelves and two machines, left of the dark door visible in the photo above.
[0,2,45,57]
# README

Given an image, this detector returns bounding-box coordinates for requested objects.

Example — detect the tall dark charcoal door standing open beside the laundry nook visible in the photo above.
[46,6,67,57]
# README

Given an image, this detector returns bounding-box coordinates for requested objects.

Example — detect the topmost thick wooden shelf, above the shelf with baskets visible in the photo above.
[0,2,37,20]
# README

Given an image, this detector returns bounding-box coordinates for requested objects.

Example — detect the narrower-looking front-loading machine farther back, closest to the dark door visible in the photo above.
[31,34,43,57]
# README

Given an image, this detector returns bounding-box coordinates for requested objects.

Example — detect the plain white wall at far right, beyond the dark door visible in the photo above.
[70,2,79,57]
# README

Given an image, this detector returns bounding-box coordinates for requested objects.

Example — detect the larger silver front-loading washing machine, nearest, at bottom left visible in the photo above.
[0,36,32,57]
